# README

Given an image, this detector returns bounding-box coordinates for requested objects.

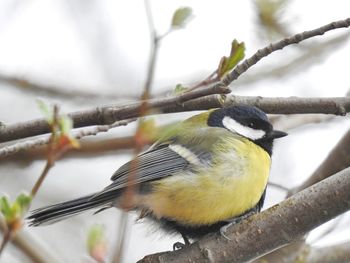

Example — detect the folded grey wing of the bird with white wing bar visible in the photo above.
[92,144,210,199]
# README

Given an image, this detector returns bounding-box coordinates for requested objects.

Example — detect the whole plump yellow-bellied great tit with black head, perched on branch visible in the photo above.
[29,106,287,243]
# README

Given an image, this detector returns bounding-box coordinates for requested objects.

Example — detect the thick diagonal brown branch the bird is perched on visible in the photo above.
[139,168,350,263]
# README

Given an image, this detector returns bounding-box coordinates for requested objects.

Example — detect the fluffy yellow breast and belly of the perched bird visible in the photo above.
[143,138,271,225]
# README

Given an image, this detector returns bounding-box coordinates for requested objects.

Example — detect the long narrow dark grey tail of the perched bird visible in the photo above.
[27,194,112,226]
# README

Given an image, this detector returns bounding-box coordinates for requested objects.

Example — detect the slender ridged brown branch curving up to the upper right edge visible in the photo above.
[0,18,350,145]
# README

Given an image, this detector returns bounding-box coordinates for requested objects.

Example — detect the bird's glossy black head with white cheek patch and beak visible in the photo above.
[208,106,287,155]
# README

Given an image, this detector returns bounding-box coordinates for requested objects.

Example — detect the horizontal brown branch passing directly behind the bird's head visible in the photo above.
[0,95,350,142]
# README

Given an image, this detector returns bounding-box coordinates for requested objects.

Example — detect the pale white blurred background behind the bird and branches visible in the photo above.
[0,0,350,262]
